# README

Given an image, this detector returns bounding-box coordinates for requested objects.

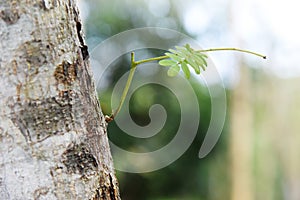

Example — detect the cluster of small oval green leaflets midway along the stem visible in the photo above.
[159,44,207,79]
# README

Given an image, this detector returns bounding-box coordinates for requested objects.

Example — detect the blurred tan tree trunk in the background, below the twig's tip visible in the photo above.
[230,63,254,200]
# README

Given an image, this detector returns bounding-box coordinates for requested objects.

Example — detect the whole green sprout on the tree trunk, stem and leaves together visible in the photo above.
[105,44,266,122]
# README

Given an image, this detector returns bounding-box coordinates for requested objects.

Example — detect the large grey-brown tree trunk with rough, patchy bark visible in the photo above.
[0,0,120,200]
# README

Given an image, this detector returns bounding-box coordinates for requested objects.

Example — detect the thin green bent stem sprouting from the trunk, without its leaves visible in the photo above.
[106,48,267,122]
